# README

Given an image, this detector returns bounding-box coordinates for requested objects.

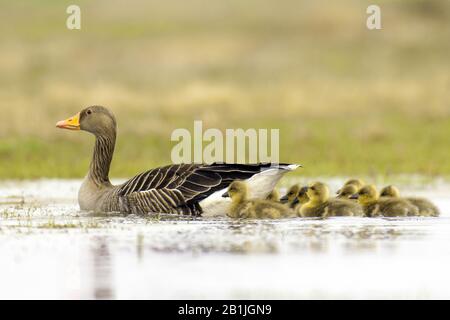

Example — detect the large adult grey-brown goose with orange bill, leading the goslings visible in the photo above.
[56,106,299,216]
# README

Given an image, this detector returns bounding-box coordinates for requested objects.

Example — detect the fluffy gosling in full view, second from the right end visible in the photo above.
[351,185,419,217]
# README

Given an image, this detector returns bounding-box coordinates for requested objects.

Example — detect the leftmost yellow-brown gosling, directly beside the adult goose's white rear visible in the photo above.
[222,180,294,219]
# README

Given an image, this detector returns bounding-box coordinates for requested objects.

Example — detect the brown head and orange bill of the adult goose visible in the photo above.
[56,106,117,136]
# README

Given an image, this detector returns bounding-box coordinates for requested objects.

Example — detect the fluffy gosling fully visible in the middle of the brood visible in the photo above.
[299,182,363,218]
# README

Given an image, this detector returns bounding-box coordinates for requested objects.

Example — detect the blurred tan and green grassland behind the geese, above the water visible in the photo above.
[0,0,450,179]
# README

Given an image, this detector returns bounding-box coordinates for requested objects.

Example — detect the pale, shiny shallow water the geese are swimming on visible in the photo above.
[0,180,450,299]
